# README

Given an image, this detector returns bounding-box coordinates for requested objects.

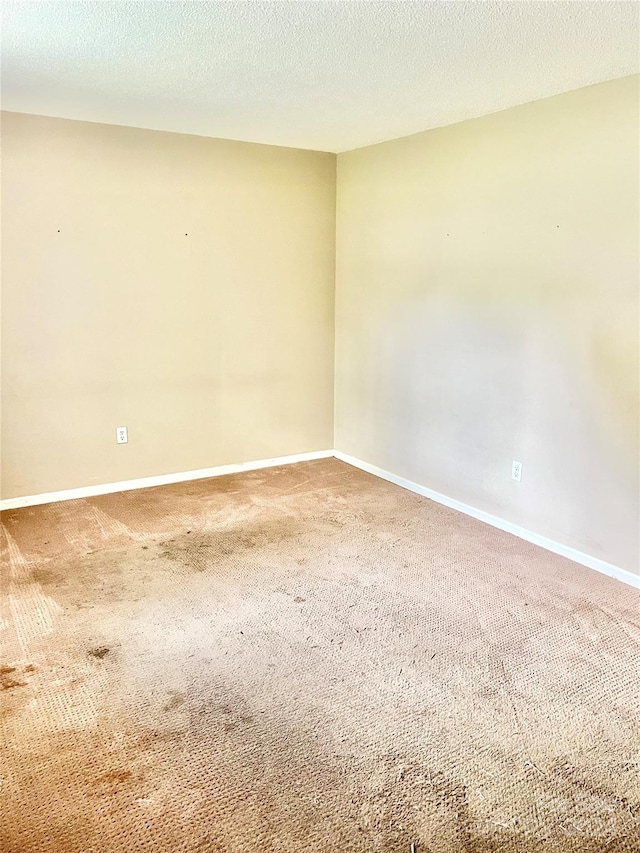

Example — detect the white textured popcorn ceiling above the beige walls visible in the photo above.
[2,0,640,151]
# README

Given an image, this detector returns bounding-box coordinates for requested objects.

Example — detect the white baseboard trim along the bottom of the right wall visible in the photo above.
[333,450,640,588]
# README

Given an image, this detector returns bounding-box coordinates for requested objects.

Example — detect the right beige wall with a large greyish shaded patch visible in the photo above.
[335,77,640,571]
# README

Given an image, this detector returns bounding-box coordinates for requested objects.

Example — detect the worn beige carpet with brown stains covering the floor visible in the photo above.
[0,459,640,853]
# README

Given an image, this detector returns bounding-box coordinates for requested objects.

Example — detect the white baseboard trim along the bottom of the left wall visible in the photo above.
[0,450,333,511]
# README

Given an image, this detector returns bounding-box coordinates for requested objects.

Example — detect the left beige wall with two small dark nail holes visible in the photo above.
[2,113,335,498]
